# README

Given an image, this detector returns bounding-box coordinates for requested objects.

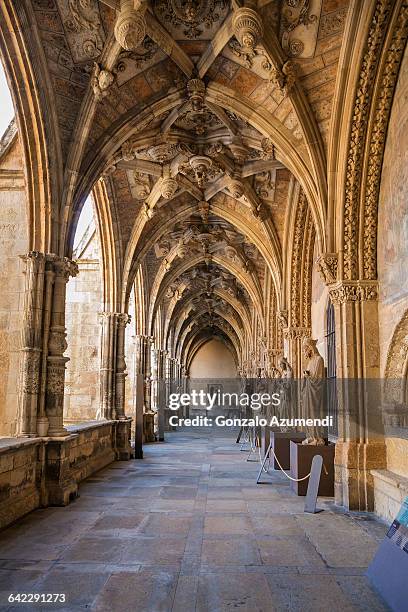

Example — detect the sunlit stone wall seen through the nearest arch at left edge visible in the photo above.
[0,133,28,436]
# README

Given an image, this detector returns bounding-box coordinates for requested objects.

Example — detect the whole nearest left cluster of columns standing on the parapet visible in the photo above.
[19,251,78,437]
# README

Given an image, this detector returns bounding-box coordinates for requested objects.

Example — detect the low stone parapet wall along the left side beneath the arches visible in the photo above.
[0,419,131,529]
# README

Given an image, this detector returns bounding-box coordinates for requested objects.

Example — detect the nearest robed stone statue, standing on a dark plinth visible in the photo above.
[302,338,325,446]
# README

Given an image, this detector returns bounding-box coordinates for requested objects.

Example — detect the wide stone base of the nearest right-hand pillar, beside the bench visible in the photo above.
[334,440,387,512]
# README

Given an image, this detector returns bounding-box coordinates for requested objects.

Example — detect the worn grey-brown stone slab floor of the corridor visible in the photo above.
[0,432,386,612]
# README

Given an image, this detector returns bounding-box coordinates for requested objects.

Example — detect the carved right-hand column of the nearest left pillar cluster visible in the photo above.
[45,257,78,437]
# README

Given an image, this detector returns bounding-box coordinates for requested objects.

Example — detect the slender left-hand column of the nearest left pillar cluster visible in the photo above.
[18,251,46,437]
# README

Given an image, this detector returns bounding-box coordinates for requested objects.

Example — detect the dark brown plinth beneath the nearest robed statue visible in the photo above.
[290,441,335,497]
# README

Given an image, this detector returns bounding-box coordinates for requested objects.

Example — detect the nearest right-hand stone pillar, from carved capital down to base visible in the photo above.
[329,281,386,511]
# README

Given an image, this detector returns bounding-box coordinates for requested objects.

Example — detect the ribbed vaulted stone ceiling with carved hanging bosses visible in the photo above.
[26,0,348,368]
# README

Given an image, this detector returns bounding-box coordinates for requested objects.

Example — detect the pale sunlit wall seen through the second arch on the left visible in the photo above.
[64,231,102,424]
